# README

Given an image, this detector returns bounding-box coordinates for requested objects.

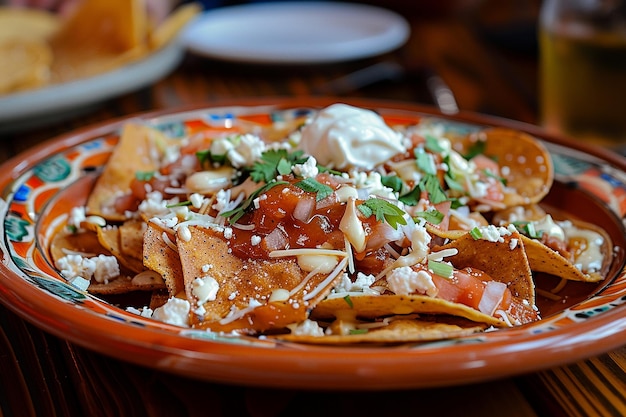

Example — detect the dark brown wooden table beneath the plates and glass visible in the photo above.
[0,2,626,417]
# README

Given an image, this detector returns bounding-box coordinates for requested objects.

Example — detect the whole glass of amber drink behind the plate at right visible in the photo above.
[539,0,626,150]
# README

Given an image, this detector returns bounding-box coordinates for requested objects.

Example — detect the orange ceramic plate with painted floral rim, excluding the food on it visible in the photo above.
[0,98,626,389]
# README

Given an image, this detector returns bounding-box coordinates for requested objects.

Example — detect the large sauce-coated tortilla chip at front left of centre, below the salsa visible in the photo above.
[178,227,347,331]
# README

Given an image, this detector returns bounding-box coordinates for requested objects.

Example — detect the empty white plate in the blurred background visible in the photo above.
[182,2,410,64]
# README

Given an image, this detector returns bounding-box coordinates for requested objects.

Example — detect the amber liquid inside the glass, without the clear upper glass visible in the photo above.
[540,25,626,147]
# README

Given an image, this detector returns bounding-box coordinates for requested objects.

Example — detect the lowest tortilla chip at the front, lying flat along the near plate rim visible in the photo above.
[273,317,486,345]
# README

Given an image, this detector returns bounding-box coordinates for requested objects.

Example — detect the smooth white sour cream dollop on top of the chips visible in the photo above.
[299,104,406,170]
